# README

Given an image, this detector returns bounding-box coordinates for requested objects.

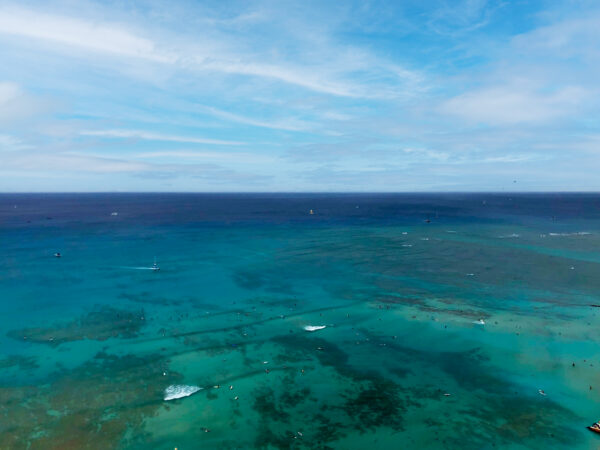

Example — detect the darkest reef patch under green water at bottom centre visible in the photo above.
[255,334,412,448]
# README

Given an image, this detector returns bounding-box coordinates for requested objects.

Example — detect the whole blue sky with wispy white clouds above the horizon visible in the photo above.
[0,0,600,192]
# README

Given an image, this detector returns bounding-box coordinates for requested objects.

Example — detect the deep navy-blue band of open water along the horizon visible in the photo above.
[0,193,600,226]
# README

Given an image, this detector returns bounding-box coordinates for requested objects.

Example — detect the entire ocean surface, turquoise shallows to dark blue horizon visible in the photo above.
[0,195,600,449]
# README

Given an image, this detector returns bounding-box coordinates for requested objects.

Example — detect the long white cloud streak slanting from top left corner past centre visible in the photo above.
[0,6,421,98]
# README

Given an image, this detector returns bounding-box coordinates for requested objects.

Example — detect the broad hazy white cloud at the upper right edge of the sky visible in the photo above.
[438,9,600,126]
